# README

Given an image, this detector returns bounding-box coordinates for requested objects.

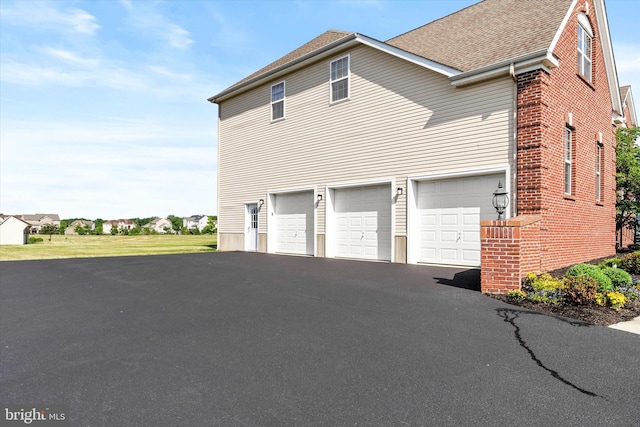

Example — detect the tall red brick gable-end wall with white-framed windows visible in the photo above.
[517,1,615,270]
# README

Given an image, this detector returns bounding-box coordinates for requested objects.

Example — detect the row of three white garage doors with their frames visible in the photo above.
[267,170,508,267]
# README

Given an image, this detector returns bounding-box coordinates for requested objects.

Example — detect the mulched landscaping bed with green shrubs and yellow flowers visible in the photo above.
[491,251,640,326]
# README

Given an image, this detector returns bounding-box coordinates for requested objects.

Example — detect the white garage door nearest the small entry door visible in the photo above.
[274,191,314,255]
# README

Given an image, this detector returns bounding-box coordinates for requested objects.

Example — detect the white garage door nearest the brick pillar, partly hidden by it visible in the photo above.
[417,173,505,267]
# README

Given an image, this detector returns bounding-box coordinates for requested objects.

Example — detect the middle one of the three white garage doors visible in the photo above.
[334,185,391,261]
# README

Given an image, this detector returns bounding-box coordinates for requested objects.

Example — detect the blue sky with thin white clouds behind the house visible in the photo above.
[0,0,640,219]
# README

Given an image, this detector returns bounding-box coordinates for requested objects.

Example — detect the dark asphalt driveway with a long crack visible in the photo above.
[0,253,640,426]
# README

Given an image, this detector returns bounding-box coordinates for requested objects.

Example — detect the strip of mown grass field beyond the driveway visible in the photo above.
[0,234,218,261]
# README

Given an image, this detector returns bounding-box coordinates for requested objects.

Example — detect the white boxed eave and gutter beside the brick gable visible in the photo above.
[449,49,559,87]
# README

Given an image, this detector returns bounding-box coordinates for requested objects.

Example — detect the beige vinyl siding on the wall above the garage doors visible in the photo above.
[219,46,513,239]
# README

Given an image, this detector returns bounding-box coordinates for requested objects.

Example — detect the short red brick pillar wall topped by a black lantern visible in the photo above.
[480,215,542,294]
